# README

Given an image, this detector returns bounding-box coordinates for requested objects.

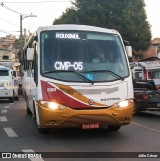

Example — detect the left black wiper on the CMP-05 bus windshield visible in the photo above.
[43,70,94,84]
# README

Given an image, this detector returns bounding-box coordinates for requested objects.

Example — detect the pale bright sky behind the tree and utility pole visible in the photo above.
[0,0,160,38]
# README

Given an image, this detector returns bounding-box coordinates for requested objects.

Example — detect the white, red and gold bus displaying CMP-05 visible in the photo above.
[23,25,134,132]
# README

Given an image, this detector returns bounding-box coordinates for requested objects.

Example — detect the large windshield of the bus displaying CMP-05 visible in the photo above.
[40,31,129,82]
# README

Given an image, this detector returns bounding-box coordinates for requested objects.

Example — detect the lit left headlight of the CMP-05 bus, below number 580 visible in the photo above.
[39,100,67,110]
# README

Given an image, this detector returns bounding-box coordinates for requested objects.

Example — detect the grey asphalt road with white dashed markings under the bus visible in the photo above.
[0,97,160,161]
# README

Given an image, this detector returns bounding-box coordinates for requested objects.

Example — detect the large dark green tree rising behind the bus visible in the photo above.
[53,0,152,57]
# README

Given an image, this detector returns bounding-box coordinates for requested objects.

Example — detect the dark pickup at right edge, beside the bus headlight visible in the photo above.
[133,80,160,114]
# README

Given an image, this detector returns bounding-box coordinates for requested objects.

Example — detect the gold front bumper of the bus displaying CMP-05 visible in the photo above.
[36,100,134,128]
